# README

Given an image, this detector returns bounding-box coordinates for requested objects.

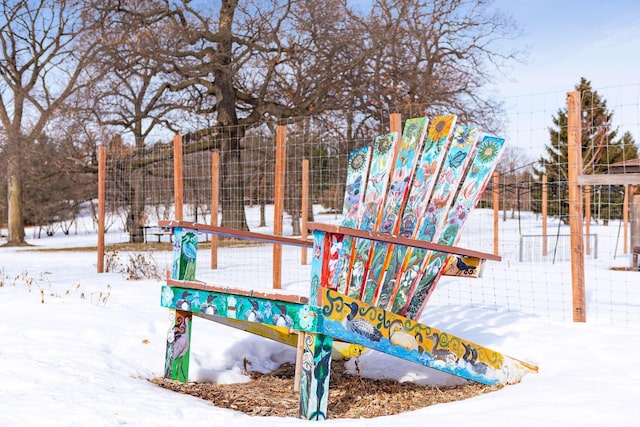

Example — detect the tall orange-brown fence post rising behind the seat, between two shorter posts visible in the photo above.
[273,125,287,289]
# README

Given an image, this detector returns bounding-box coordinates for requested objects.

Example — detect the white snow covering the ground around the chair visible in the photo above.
[0,207,640,427]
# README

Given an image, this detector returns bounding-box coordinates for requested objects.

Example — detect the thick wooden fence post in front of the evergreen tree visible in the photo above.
[567,91,587,322]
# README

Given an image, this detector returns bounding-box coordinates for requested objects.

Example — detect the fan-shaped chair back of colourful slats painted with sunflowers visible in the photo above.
[310,115,504,319]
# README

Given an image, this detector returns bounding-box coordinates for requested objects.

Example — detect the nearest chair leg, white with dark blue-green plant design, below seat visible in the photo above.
[299,333,333,420]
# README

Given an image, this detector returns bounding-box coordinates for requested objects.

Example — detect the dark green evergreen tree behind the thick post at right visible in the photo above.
[532,77,638,219]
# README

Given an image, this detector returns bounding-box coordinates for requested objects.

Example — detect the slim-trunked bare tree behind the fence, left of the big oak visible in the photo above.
[87,1,180,243]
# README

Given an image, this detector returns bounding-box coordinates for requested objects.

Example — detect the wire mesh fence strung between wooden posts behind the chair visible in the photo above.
[99,86,640,323]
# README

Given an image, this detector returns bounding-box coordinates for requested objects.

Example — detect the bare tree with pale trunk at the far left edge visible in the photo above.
[0,0,100,245]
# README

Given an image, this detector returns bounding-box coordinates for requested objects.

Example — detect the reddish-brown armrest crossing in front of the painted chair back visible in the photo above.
[308,222,502,261]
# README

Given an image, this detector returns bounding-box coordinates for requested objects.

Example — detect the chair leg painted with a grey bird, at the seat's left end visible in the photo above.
[164,310,192,382]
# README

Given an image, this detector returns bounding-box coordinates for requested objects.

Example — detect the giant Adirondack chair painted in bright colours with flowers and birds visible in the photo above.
[160,116,537,420]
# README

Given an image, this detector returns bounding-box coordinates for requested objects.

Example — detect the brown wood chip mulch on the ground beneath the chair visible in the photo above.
[151,361,502,418]
